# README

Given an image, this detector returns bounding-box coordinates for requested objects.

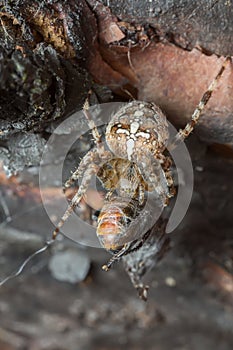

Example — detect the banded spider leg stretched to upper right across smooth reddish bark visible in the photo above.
[169,57,231,150]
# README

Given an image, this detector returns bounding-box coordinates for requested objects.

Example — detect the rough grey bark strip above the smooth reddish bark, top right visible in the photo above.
[101,0,233,56]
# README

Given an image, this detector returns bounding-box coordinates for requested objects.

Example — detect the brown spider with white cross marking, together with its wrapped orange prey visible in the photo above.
[52,57,231,271]
